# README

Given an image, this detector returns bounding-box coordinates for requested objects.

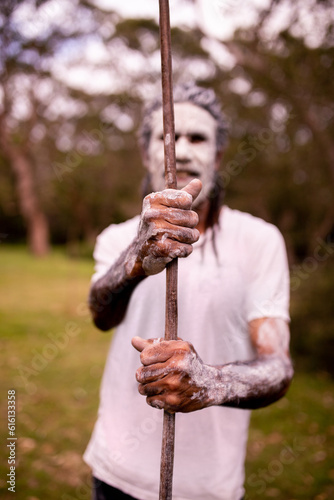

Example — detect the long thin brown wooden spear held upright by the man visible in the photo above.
[159,0,178,500]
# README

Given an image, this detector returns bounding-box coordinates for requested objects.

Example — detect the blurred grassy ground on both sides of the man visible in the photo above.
[0,246,334,500]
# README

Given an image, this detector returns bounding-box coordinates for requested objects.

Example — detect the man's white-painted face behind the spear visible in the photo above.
[147,102,217,206]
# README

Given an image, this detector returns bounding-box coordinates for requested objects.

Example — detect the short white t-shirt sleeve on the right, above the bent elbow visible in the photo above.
[246,224,290,322]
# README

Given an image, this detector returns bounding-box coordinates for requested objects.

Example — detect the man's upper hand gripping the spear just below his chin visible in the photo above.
[128,179,202,275]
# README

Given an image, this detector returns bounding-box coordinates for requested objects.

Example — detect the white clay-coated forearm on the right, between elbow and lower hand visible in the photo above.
[207,355,293,409]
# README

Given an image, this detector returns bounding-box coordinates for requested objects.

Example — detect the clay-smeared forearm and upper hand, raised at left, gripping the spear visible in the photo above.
[89,179,202,331]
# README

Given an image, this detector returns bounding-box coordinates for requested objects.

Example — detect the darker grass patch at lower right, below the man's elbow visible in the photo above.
[246,373,334,500]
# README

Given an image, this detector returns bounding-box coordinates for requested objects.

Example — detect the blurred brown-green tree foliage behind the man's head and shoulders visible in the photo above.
[0,0,334,258]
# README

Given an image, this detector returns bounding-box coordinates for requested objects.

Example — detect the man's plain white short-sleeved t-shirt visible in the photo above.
[84,206,289,500]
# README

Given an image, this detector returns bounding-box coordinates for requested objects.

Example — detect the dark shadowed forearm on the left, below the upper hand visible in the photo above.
[89,243,146,331]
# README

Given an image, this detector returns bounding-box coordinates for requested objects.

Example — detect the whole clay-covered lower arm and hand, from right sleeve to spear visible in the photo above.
[132,318,293,413]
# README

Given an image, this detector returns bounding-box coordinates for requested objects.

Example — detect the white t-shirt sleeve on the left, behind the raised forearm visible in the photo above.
[92,217,139,283]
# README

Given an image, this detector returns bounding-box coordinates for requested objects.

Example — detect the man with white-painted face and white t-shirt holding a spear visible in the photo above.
[85,85,293,500]
